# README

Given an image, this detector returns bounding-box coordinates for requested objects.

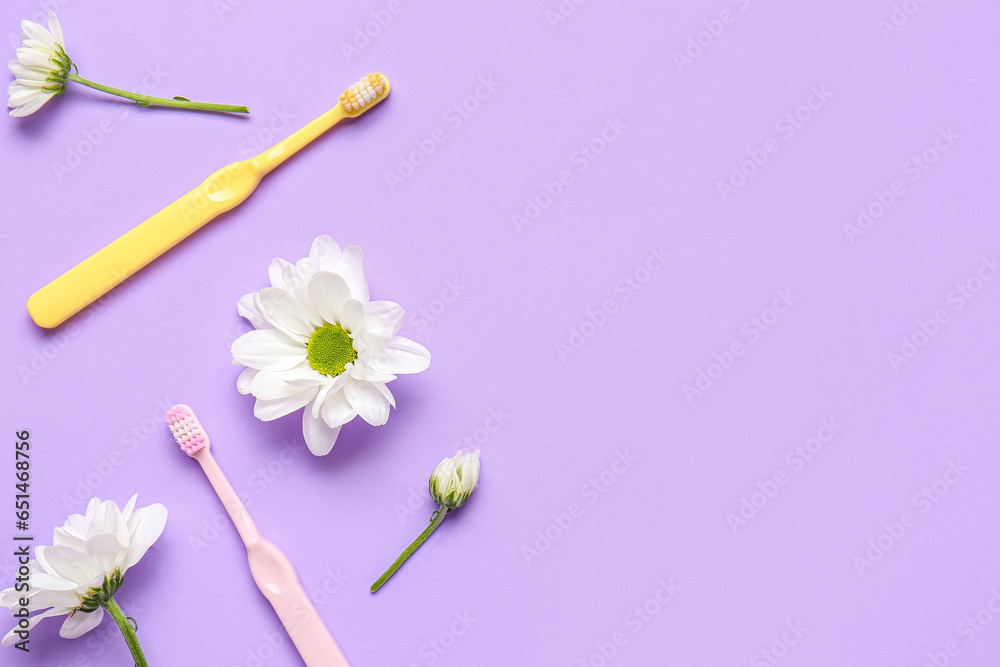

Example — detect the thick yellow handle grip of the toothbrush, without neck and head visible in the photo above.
[28,160,262,329]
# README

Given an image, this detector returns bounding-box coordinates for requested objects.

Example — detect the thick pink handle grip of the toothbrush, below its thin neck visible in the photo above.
[247,539,350,667]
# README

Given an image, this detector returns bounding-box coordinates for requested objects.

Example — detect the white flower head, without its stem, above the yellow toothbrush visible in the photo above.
[7,12,73,116]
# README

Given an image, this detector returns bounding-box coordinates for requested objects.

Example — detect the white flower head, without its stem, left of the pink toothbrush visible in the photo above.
[0,496,167,646]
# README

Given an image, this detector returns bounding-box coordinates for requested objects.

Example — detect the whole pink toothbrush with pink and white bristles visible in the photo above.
[167,405,350,667]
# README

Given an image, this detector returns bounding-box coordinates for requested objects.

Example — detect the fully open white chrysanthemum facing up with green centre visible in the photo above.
[232,236,431,456]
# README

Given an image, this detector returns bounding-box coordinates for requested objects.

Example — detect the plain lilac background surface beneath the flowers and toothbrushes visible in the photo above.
[0,0,1000,667]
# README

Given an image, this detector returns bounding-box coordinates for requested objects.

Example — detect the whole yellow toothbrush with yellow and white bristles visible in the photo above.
[28,73,389,329]
